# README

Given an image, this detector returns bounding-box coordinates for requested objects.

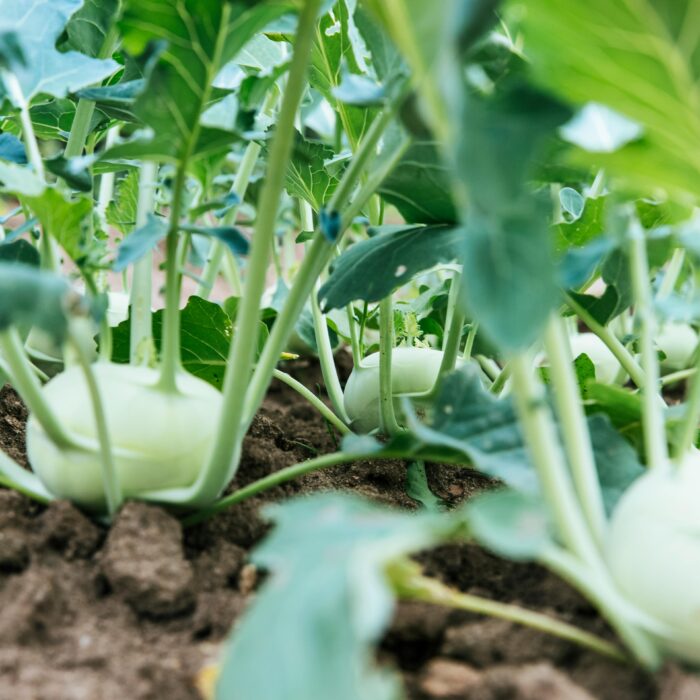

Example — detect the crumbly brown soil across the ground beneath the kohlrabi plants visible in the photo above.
[0,363,700,700]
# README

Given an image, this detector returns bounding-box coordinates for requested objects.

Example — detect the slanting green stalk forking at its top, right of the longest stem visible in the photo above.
[245,103,410,425]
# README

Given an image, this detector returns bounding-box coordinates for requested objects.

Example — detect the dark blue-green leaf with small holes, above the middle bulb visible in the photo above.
[318,226,463,311]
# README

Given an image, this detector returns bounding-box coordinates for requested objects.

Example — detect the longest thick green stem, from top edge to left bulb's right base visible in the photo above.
[196,0,320,501]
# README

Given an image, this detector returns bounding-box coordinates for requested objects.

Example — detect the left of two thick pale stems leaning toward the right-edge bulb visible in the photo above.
[511,354,600,566]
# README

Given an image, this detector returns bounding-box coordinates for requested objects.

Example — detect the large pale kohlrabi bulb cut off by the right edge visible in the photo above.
[607,448,700,664]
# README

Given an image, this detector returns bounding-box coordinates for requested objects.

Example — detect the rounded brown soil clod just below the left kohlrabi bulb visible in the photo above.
[101,503,194,617]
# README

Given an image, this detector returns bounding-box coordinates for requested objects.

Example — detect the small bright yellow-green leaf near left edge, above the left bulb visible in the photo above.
[21,188,92,261]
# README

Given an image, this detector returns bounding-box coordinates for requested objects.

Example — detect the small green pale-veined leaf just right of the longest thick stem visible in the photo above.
[285,133,339,212]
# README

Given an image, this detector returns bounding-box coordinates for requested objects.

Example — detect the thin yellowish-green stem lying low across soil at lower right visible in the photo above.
[388,560,629,663]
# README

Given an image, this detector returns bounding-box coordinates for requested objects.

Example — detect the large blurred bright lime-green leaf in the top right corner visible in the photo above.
[522,0,700,195]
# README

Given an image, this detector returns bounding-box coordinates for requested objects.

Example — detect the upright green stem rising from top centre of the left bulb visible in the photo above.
[158,164,187,393]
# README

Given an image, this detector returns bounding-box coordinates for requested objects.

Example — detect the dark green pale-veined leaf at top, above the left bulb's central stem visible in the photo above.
[112,0,288,161]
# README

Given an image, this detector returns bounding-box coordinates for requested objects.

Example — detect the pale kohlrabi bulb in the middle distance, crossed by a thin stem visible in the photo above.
[344,348,442,433]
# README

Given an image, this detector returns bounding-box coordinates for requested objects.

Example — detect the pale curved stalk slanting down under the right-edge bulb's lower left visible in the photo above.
[539,548,661,670]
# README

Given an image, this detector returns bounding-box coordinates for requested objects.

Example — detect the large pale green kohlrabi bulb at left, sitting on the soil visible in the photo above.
[27,362,222,510]
